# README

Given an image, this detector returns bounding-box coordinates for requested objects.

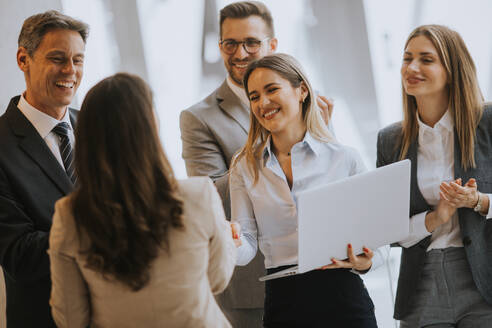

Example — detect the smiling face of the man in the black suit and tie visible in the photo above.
[17,29,85,119]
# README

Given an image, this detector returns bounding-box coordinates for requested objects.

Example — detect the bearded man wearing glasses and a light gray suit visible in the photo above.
[180,1,332,328]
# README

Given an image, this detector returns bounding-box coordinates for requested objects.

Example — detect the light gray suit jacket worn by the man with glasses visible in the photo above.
[180,81,265,311]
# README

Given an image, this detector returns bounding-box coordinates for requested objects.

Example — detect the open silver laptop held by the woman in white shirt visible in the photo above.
[260,160,410,281]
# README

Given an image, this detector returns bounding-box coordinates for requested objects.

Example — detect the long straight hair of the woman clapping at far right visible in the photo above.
[400,25,483,170]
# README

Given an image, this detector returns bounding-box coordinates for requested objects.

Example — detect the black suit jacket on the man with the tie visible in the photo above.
[0,96,76,328]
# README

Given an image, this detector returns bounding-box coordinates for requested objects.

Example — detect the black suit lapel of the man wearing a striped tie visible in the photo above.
[5,98,73,194]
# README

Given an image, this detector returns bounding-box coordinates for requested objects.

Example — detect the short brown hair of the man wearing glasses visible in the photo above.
[219,1,275,39]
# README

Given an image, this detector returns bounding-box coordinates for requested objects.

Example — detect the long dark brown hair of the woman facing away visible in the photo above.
[72,73,183,290]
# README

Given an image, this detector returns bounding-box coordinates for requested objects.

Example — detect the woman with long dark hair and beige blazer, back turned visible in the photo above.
[49,73,236,328]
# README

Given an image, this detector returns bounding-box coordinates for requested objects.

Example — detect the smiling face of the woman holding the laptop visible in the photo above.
[248,68,308,134]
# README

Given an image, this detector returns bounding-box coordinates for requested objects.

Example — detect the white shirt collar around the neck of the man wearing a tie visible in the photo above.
[17,94,72,139]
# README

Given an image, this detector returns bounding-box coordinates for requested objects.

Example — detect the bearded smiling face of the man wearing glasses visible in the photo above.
[220,16,277,87]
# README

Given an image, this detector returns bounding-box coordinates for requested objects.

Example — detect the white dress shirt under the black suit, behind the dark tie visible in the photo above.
[17,95,74,170]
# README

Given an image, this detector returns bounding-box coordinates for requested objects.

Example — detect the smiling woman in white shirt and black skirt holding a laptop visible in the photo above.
[230,54,382,327]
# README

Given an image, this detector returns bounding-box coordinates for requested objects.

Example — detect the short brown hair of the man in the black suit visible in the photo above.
[18,10,89,57]
